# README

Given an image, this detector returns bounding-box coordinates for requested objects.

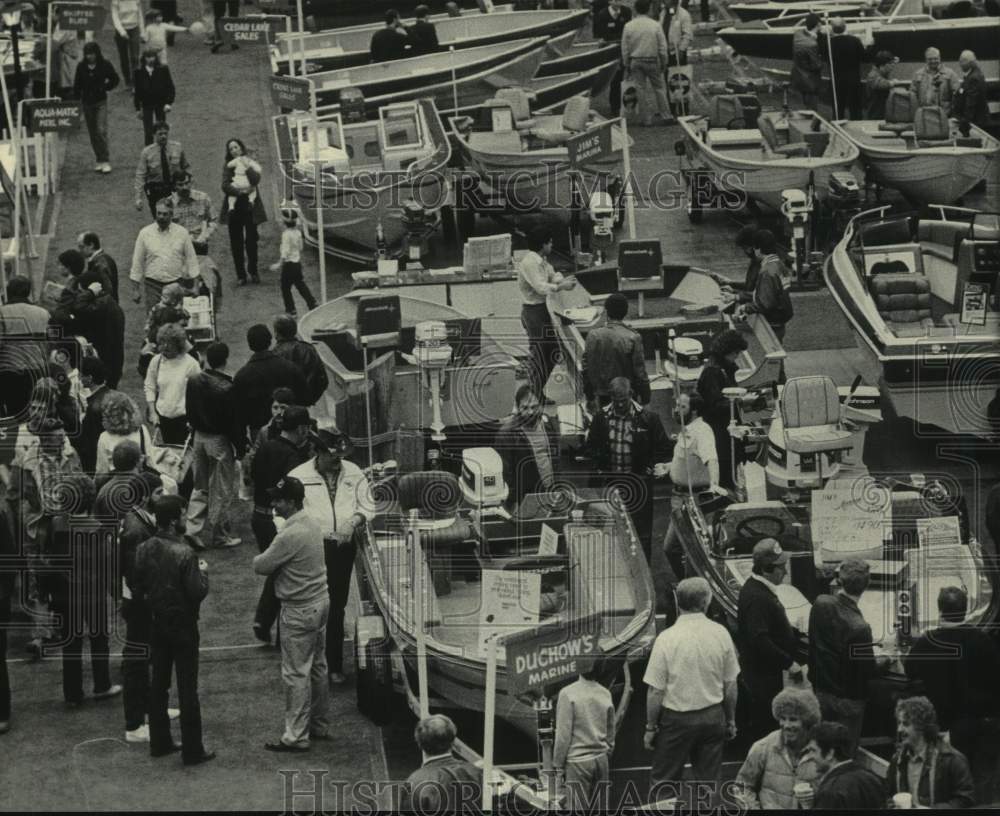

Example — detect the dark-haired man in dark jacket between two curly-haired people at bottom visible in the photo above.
[799,722,885,812]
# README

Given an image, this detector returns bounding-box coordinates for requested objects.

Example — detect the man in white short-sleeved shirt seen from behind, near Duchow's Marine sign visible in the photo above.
[643,578,740,809]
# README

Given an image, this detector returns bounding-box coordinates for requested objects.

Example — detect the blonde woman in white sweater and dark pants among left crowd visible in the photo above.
[145,323,201,445]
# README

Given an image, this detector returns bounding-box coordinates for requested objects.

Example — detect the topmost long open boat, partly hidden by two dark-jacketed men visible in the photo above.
[271,9,587,75]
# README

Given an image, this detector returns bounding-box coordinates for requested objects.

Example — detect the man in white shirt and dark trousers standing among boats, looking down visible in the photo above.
[517,230,576,405]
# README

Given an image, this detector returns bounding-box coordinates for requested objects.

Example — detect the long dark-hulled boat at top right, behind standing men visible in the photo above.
[717,0,1000,83]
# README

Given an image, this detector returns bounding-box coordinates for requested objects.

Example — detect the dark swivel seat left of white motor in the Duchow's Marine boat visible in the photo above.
[399,470,479,596]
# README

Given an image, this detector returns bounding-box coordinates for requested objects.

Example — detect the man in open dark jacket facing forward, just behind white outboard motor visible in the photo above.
[493,383,559,507]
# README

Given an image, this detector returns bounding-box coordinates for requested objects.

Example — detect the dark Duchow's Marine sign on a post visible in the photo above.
[504,615,602,696]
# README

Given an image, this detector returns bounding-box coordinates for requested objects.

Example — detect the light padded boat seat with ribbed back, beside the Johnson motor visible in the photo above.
[781,376,853,454]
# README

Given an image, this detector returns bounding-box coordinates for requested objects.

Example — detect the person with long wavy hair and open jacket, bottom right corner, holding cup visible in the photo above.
[886,697,976,810]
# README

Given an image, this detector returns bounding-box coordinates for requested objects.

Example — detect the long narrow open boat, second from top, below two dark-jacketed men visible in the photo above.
[310,37,547,105]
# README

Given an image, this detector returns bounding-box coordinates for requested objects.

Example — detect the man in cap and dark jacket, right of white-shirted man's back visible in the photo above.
[736,538,801,742]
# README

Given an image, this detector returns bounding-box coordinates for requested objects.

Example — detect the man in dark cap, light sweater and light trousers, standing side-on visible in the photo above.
[253,476,330,753]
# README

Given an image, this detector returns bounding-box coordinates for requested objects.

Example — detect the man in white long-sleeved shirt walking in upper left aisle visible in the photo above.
[129,198,201,303]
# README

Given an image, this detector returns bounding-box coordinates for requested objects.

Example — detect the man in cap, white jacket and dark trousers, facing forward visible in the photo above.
[288,425,375,685]
